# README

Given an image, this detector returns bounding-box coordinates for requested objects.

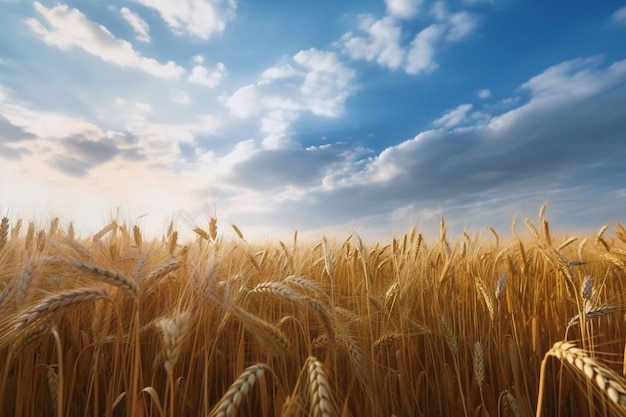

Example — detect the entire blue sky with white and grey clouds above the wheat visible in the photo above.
[0,0,626,239]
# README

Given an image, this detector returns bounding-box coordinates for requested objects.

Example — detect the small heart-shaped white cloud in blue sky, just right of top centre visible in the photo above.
[340,16,405,69]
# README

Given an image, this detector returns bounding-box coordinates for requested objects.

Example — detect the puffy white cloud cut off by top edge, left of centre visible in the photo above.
[135,0,237,39]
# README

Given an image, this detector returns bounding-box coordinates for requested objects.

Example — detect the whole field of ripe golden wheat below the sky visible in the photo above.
[0,210,626,417]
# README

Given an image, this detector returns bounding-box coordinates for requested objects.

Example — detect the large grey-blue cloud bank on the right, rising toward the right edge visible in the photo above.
[213,58,626,236]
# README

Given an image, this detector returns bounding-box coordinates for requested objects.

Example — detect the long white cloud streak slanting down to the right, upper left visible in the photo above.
[26,2,185,79]
